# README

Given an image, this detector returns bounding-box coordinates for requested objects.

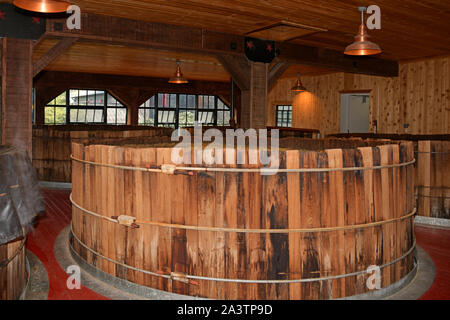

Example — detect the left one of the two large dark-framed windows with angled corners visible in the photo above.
[45,89,127,125]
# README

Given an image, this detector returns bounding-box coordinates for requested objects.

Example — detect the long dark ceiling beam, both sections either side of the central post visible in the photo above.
[46,14,398,77]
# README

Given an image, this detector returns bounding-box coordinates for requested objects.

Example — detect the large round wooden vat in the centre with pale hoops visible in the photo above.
[72,139,415,299]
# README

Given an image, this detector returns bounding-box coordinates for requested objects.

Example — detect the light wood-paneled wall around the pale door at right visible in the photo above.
[267,56,450,135]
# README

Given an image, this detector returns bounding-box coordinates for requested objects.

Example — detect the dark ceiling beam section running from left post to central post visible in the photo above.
[46,13,244,55]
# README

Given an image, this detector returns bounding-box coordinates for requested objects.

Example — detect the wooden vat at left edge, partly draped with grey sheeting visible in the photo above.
[0,146,45,300]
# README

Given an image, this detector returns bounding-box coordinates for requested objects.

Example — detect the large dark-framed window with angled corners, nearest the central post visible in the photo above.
[139,93,231,128]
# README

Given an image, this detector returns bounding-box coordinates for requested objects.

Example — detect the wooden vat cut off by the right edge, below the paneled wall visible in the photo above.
[416,141,450,219]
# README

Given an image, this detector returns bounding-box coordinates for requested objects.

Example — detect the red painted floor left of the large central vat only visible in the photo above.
[27,190,107,300]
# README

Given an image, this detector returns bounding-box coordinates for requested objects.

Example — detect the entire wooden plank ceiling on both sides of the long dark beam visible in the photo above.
[15,0,450,81]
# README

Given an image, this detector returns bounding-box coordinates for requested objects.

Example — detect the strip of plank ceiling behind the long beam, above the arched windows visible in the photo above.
[33,39,331,81]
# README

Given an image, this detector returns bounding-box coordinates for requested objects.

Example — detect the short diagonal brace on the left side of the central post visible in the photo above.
[217,54,250,90]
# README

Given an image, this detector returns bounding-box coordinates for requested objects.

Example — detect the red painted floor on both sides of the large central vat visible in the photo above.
[27,189,450,300]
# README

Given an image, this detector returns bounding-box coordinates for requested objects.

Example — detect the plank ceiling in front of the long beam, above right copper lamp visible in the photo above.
[57,0,450,60]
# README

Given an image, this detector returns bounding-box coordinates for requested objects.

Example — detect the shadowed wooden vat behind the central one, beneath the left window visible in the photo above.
[33,125,171,182]
